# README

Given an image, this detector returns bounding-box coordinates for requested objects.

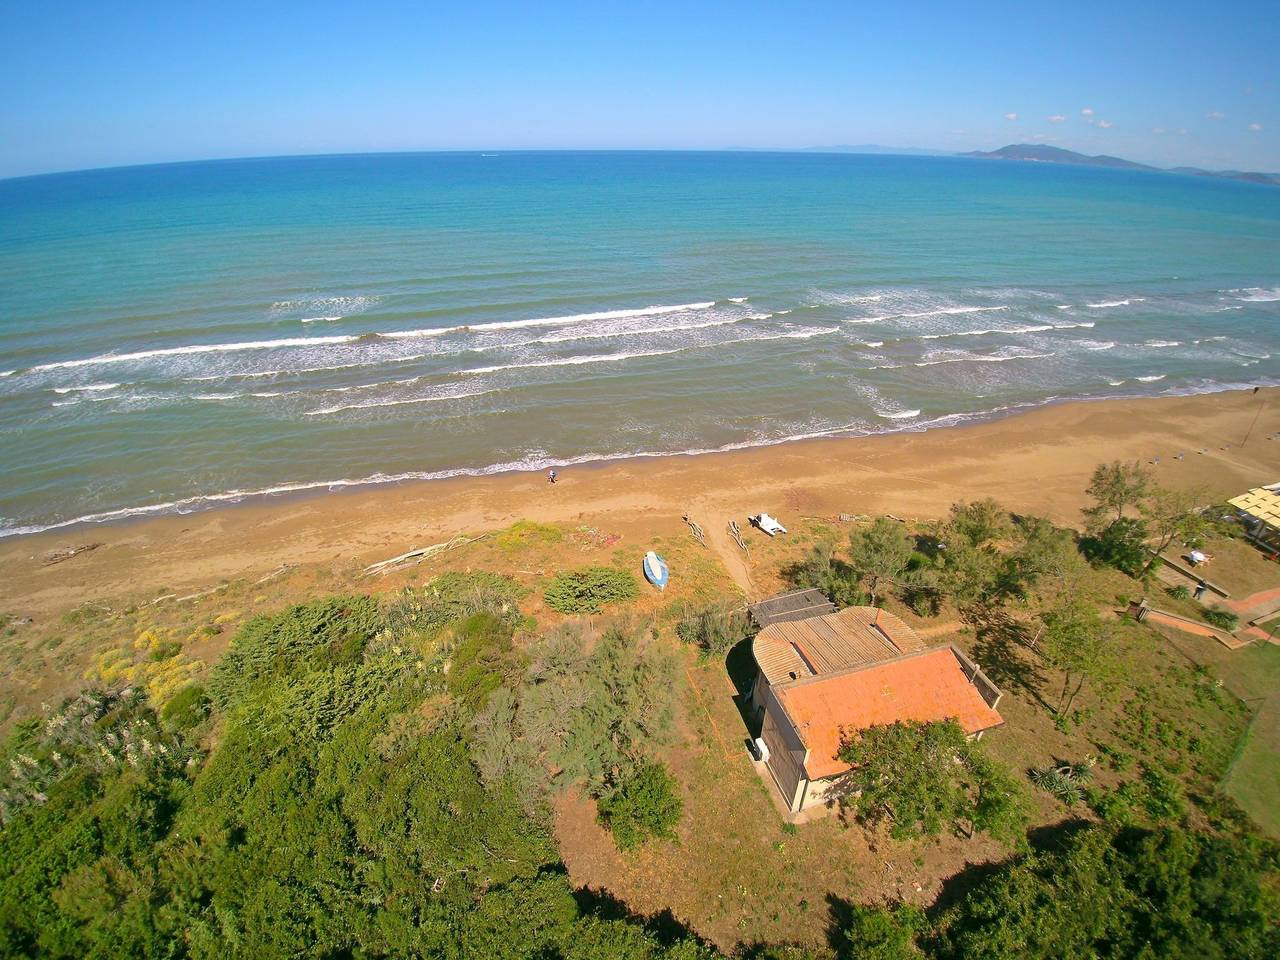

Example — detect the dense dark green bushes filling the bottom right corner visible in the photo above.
[929,824,1280,960]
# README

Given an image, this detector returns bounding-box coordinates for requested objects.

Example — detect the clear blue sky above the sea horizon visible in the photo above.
[0,0,1280,177]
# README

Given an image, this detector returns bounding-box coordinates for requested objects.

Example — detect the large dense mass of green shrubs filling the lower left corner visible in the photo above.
[0,598,714,960]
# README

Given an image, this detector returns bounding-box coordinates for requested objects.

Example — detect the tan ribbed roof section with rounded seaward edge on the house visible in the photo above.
[751,607,924,685]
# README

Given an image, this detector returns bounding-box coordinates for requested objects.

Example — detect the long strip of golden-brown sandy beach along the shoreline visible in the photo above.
[0,389,1280,617]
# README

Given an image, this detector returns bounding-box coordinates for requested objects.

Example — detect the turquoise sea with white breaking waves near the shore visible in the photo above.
[0,154,1280,535]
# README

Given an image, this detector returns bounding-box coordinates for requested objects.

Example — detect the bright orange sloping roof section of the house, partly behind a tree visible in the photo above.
[774,646,1005,780]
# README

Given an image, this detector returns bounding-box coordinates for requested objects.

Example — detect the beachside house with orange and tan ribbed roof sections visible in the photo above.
[751,602,1004,813]
